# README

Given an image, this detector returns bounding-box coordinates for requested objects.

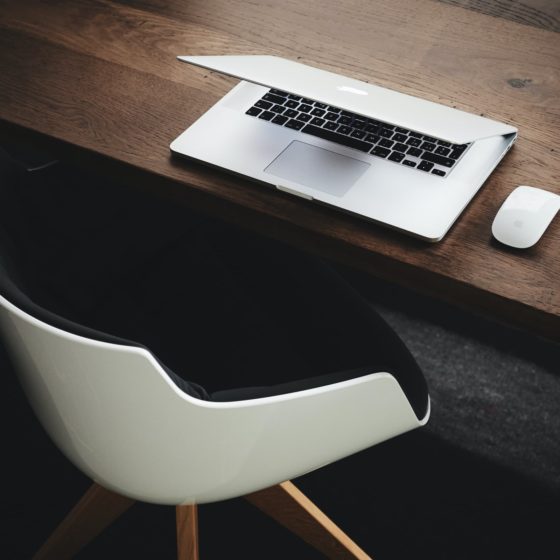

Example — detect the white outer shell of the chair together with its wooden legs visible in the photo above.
[0,256,429,560]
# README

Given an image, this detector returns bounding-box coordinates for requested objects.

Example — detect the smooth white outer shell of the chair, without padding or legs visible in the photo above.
[0,290,429,504]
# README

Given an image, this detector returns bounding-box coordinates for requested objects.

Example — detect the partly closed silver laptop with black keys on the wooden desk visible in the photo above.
[170,56,517,242]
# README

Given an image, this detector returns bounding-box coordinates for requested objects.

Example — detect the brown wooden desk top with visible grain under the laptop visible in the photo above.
[0,0,560,340]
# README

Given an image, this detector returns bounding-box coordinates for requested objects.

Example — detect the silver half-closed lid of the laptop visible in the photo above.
[177,55,517,144]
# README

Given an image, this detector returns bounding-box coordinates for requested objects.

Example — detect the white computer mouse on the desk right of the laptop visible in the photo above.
[492,186,560,249]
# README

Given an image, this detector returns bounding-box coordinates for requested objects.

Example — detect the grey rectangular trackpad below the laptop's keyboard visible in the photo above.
[265,140,369,196]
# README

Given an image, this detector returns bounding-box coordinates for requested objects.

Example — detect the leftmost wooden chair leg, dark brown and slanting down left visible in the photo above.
[33,483,134,560]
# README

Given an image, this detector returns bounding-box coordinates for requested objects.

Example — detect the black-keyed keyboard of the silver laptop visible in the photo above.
[246,89,470,177]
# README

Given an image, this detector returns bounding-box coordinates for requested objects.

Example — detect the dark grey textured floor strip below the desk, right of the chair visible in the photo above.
[368,282,560,489]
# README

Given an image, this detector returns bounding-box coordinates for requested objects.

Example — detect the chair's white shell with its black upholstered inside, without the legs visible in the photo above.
[0,143,429,505]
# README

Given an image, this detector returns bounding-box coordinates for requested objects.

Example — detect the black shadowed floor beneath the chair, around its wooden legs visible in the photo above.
[0,336,560,560]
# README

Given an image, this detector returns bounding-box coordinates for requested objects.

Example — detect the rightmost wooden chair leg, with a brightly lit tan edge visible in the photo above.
[245,481,371,560]
